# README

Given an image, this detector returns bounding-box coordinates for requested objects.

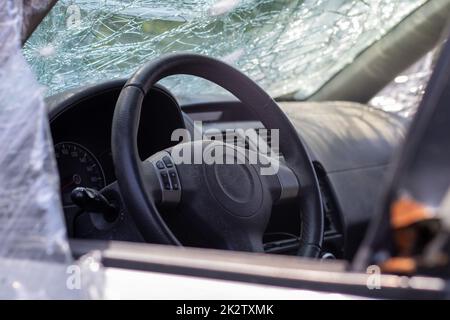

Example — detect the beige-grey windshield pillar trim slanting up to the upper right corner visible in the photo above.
[308,0,450,103]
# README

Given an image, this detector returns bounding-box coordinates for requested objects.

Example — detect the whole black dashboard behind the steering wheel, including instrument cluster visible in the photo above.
[47,80,404,259]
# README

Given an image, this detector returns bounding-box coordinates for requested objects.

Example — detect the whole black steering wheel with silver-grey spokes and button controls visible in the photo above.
[111,54,324,257]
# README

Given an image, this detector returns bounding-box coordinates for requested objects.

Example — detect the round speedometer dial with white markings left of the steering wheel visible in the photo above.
[55,142,106,206]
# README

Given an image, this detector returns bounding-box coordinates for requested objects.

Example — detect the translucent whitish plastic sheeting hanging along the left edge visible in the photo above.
[0,0,101,299]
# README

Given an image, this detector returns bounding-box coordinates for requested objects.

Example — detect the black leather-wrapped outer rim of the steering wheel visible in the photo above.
[111,54,324,257]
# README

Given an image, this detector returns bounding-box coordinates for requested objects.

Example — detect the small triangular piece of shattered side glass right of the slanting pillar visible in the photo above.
[369,49,437,118]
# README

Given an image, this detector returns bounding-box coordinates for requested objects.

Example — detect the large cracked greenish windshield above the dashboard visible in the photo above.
[24,0,426,99]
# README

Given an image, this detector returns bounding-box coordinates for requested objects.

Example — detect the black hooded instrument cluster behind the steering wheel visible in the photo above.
[50,82,184,207]
